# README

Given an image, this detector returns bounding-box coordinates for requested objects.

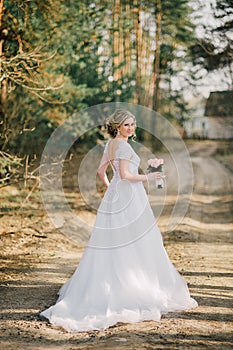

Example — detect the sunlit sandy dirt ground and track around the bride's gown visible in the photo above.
[0,141,233,350]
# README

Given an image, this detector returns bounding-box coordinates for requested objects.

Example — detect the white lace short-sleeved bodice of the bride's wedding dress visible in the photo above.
[104,141,140,176]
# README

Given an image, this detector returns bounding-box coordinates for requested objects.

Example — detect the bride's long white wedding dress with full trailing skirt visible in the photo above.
[40,141,197,332]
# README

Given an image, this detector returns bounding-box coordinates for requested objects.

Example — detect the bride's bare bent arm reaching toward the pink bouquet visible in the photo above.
[119,159,161,181]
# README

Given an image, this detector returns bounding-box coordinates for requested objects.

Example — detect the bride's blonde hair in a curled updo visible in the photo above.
[106,109,136,137]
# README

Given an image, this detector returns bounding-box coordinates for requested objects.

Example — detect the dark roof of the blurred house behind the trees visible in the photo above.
[205,91,233,117]
